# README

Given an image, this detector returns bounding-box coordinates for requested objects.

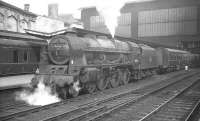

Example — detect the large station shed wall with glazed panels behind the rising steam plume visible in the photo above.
[81,0,200,53]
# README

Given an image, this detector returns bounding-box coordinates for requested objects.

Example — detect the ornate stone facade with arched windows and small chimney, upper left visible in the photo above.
[0,1,37,32]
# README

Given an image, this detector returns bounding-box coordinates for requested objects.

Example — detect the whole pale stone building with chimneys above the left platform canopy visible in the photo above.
[0,0,64,33]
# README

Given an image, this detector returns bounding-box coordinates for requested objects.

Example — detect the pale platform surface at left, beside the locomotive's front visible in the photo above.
[0,74,34,90]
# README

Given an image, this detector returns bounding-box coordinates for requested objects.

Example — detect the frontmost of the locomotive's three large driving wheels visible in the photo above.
[96,74,108,91]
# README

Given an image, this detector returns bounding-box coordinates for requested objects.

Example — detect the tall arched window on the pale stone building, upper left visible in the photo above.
[7,16,17,32]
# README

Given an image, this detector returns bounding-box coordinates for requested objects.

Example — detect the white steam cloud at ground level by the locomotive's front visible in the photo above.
[17,81,60,106]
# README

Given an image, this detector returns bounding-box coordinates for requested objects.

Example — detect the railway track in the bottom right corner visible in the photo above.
[140,80,200,121]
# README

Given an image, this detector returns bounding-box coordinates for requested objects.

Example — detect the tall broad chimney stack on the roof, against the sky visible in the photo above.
[48,4,58,18]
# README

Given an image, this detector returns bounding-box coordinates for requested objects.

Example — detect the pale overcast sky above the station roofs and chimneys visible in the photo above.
[3,0,152,17]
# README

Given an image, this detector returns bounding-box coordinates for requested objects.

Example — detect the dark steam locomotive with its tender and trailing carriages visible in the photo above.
[31,27,198,98]
